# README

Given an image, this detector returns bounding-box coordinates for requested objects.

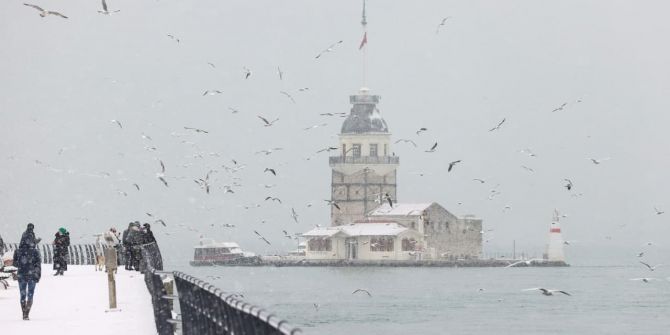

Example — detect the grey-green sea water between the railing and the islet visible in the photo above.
[173,267,670,335]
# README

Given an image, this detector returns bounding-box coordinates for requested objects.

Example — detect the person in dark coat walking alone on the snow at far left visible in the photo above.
[13,223,42,320]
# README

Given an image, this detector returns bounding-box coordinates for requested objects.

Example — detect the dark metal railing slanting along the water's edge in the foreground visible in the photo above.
[140,243,302,335]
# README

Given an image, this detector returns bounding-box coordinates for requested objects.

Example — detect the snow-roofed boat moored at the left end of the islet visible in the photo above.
[190,239,261,266]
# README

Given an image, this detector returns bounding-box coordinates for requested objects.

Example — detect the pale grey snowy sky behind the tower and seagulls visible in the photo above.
[0,0,670,263]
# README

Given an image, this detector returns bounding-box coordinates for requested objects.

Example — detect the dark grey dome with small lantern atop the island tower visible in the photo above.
[340,87,388,134]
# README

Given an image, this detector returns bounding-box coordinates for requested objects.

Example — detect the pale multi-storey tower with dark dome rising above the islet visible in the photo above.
[330,88,400,226]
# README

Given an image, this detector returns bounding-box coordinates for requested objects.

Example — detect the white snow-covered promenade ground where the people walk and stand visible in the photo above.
[0,264,156,335]
